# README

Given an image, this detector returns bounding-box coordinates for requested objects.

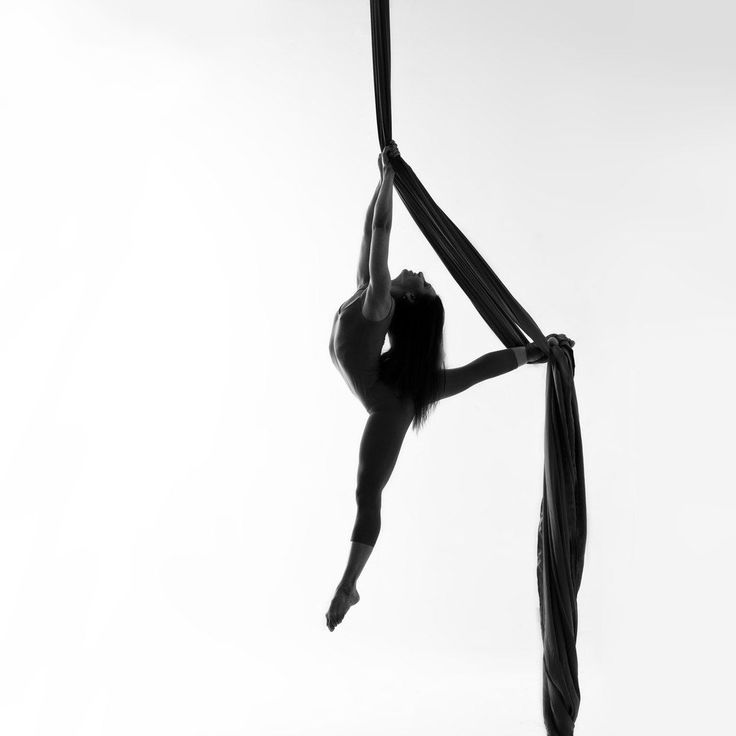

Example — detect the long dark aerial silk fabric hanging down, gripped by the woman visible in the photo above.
[370,0,586,736]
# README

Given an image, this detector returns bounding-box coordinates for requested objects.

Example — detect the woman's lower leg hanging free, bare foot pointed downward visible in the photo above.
[326,403,413,631]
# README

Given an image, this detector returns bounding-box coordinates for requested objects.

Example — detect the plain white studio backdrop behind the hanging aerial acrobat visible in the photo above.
[0,0,736,736]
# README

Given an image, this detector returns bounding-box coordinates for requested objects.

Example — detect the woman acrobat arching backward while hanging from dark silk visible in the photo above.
[325,142,547,631]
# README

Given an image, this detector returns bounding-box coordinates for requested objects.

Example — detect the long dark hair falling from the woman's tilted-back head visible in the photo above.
[378,294,445,432]
